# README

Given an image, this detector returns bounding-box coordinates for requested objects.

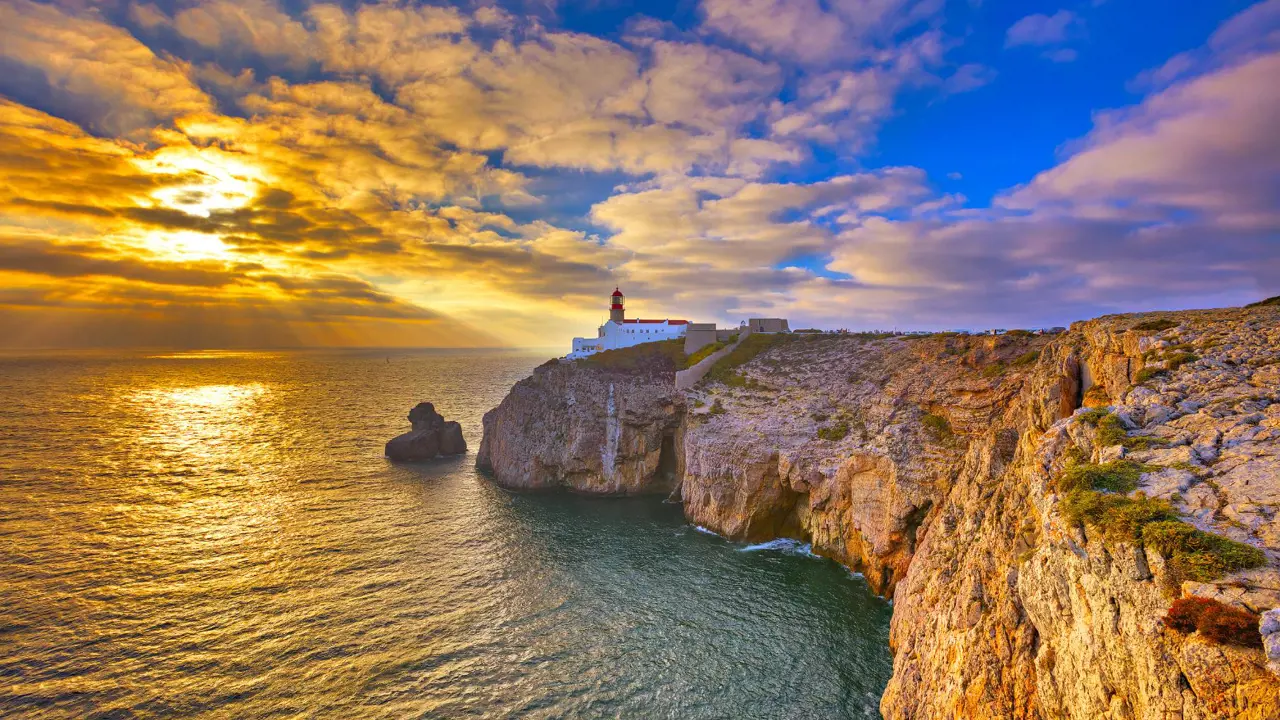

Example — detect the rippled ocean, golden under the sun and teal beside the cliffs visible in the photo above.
[0,350,891,719]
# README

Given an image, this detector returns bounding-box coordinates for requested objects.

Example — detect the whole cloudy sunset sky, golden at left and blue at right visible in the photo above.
[0,0,1280,350]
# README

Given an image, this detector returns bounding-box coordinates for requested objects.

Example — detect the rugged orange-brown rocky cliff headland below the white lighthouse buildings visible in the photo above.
[481,306,1280,719]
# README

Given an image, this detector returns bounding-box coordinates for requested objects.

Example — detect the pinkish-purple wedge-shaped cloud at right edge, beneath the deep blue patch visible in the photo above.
[998,54,1280,231]
